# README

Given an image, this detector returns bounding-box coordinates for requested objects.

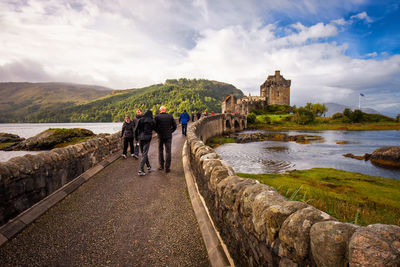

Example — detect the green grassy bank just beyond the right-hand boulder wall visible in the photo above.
[237,168,400,226]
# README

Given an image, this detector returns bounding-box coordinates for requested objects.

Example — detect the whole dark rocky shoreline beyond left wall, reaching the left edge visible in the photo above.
[0,128,95,151]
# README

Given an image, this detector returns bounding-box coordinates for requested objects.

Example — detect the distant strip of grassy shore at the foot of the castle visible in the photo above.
[248,114,400,131]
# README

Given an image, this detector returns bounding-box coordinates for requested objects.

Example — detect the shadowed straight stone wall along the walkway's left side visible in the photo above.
[0,133,121,225]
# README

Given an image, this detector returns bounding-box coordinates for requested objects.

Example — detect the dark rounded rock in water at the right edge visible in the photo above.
[370,146,400,168]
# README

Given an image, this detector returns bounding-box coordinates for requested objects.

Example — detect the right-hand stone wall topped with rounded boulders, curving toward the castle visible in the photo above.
[187,114,400,266]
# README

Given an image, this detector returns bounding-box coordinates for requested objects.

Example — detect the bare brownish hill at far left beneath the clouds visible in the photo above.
[0,82,111,122]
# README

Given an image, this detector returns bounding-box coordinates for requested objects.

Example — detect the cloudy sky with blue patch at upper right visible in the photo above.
[0,0,400,115]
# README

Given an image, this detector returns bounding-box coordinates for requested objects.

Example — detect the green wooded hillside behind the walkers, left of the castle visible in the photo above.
[19,79,243,122]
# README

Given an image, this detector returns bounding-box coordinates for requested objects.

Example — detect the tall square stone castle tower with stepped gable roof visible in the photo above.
[260,70,291,106]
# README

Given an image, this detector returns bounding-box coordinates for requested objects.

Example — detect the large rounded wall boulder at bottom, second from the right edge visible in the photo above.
[310,221,359,267]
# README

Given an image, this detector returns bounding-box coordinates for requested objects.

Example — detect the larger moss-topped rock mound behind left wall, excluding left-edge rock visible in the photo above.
[13,128,95,150]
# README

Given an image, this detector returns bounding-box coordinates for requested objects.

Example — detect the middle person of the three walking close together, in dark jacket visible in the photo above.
[137,110,154,176]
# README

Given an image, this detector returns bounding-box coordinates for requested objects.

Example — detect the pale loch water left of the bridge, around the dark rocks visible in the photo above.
[0,122,122,162]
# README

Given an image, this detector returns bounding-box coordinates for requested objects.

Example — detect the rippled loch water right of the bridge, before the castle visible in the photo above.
[215,130,400,180]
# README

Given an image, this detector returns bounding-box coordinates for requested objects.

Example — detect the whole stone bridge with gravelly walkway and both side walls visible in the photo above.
[0,114,400,266]
